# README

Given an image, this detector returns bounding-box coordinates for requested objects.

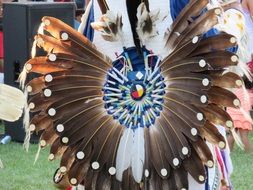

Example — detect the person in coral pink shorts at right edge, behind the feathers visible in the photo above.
[227,0,253,153]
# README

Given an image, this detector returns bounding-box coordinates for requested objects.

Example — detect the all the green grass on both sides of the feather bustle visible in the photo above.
[0,126,253,190]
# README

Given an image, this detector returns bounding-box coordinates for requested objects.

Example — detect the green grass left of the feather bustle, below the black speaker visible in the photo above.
[0,123,58,190]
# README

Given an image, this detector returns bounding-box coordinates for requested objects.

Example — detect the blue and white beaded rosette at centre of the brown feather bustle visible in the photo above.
[103,48,166,129]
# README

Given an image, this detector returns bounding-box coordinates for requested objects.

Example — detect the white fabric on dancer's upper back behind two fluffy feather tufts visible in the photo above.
[93,0,172,60]
